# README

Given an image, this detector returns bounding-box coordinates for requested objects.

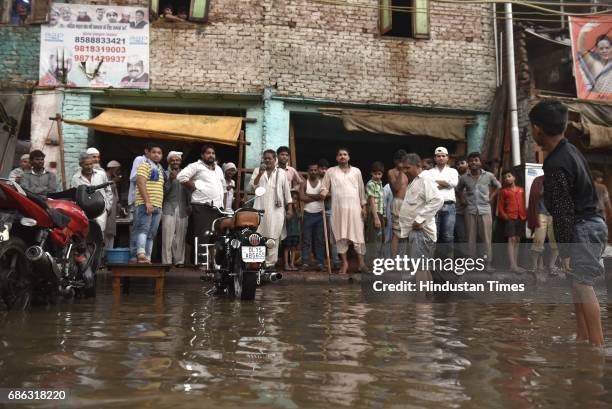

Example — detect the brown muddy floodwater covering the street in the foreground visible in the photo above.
[0,279,612,409]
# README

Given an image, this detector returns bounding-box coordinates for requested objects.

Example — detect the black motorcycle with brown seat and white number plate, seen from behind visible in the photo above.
[195,186,282,300]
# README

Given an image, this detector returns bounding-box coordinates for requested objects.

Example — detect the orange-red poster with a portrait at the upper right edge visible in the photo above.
[570,15,612,101]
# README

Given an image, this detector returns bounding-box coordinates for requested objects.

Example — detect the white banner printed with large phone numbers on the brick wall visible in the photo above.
[38,3,149,89]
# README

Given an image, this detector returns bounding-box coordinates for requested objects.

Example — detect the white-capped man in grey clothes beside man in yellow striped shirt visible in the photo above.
[161,151,191,266]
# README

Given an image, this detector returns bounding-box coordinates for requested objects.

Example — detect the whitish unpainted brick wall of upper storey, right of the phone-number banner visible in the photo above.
[151,0,495,109]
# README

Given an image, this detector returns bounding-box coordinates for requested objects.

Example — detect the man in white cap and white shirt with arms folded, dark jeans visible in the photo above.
[426,146,459,257]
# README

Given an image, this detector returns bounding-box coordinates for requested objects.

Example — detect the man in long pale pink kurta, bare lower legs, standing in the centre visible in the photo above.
[321,149,367,273]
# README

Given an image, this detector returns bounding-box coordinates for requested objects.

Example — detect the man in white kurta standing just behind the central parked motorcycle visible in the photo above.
[249,150,293,268]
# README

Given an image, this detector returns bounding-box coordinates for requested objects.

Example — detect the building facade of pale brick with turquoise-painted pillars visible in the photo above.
[0,0,496,181]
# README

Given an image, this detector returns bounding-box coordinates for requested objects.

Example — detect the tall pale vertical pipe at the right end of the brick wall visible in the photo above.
[504,3,521,166]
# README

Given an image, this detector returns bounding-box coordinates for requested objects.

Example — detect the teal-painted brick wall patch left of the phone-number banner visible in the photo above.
[0,26,40,88]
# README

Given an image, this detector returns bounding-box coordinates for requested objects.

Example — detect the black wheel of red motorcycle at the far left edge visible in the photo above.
[0,237,33,310]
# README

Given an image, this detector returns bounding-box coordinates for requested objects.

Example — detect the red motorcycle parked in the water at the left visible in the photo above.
[0,179,112,309]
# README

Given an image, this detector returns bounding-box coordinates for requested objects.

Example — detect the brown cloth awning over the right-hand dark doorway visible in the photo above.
[320,108,473,141]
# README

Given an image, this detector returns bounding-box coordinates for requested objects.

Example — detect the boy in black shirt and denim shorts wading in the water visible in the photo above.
[529,100,608,346]
